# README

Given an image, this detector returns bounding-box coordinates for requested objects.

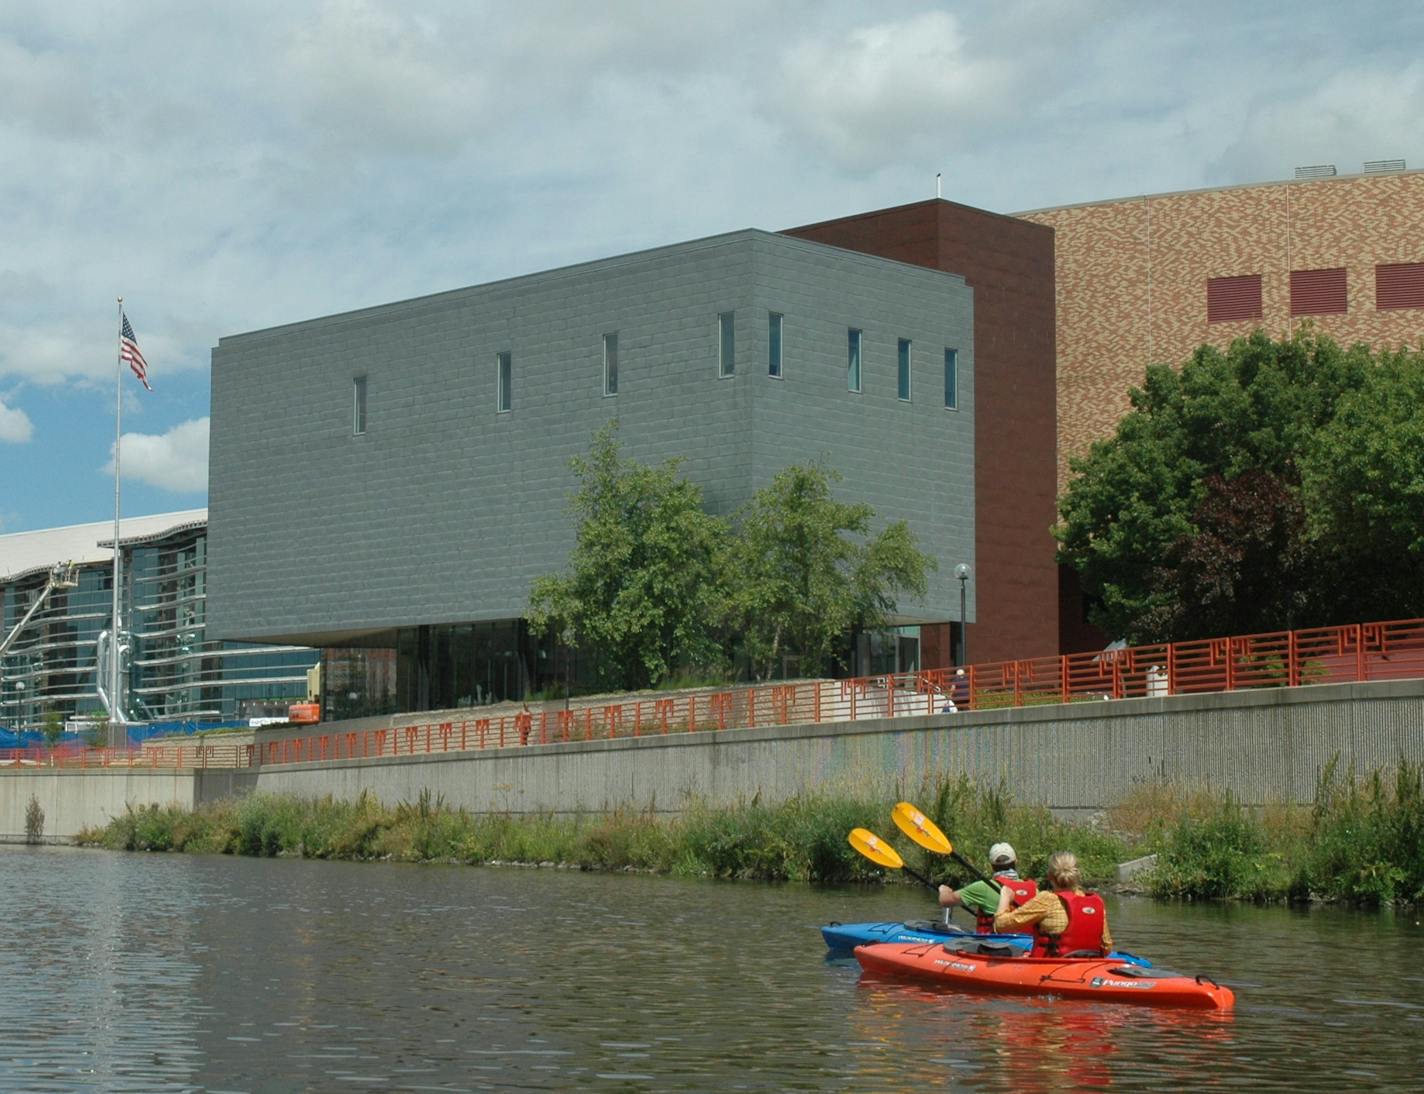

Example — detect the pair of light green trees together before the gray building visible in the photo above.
[530,423,934,688]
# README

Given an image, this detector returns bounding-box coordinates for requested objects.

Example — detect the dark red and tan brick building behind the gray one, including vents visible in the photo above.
[787,173,1424,665]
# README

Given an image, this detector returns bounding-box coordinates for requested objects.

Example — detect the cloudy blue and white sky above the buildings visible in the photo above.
[0,0,1424,534]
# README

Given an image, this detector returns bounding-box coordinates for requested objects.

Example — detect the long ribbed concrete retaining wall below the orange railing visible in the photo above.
[0,681,1424,839]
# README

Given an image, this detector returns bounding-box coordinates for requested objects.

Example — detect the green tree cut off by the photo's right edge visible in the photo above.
[1300,350,1424,620]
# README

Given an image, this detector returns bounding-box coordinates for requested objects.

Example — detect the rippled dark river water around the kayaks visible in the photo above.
[0,848,1424,1093]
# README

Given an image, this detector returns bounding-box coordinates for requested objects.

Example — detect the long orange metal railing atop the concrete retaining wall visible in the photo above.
[0,620,1424,772]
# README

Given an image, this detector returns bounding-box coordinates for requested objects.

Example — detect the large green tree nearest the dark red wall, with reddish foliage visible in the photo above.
[1054,332,1377,642]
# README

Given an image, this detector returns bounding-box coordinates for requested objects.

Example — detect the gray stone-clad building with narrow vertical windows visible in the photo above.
[208,229,975,709]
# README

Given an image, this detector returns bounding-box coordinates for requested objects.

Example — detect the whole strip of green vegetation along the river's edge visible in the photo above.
[77,762,1424,906]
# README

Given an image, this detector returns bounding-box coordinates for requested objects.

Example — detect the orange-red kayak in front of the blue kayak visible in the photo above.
[856,942,1236,1010]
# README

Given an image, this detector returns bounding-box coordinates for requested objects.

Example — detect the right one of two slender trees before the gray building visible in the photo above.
[725,464,934,679]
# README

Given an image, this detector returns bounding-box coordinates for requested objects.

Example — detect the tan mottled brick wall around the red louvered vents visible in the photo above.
[1021,171,1424,493]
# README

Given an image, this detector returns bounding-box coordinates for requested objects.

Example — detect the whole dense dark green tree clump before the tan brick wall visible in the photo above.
[1054,332,1424,642]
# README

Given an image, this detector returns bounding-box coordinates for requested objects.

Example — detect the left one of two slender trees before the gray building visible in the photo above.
[530,422,726,688]
